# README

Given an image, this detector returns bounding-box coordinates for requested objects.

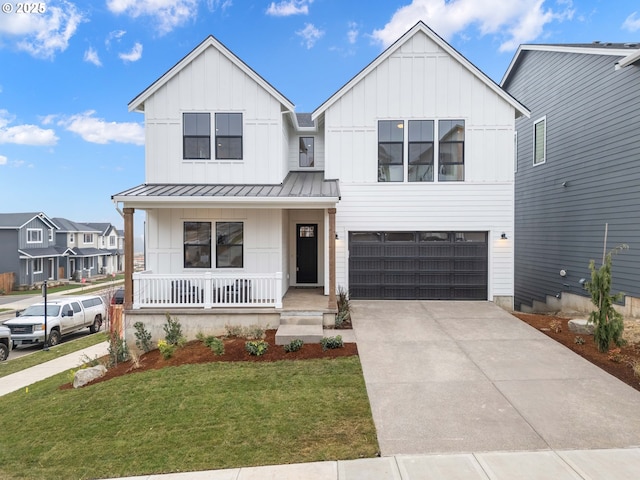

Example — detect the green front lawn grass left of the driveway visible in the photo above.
[0,357,378,479]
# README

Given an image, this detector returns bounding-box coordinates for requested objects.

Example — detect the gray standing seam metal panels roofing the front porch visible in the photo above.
[111,171,340,206]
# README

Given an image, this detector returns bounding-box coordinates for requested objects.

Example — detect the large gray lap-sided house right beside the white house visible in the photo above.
[501,42,640,315]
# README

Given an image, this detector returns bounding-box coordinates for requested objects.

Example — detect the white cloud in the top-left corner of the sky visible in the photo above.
[0,0,85,59]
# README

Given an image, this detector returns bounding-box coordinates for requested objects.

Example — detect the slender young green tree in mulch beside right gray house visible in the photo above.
[585,245,629,352]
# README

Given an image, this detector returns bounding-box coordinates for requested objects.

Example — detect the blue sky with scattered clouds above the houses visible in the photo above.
[0,0,640,248]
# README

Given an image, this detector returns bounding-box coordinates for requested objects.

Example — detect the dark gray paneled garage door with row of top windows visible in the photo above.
[349,232,487,300]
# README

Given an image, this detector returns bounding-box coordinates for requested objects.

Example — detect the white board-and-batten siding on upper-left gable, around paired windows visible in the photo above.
[144,47,288,184]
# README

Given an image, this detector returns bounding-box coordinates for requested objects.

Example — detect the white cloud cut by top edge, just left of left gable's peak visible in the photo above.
[107,0,198,35]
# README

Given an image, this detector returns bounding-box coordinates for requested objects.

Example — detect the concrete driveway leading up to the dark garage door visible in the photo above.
[352,300,640,456]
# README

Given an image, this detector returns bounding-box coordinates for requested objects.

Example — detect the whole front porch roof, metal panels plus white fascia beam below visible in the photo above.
[111,171,340,208]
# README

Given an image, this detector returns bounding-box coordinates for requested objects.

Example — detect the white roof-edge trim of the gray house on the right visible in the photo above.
[500,42,640,85]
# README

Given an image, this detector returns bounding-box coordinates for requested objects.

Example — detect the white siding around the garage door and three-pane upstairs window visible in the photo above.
[324,32,515,299]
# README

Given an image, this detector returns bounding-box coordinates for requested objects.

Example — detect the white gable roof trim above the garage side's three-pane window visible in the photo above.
[312,21,530,120]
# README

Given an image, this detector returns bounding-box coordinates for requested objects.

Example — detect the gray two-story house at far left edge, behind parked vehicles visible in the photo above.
[0,212,67,287]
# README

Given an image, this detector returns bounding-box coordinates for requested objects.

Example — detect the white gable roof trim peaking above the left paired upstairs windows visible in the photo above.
[129,35,295,112]
